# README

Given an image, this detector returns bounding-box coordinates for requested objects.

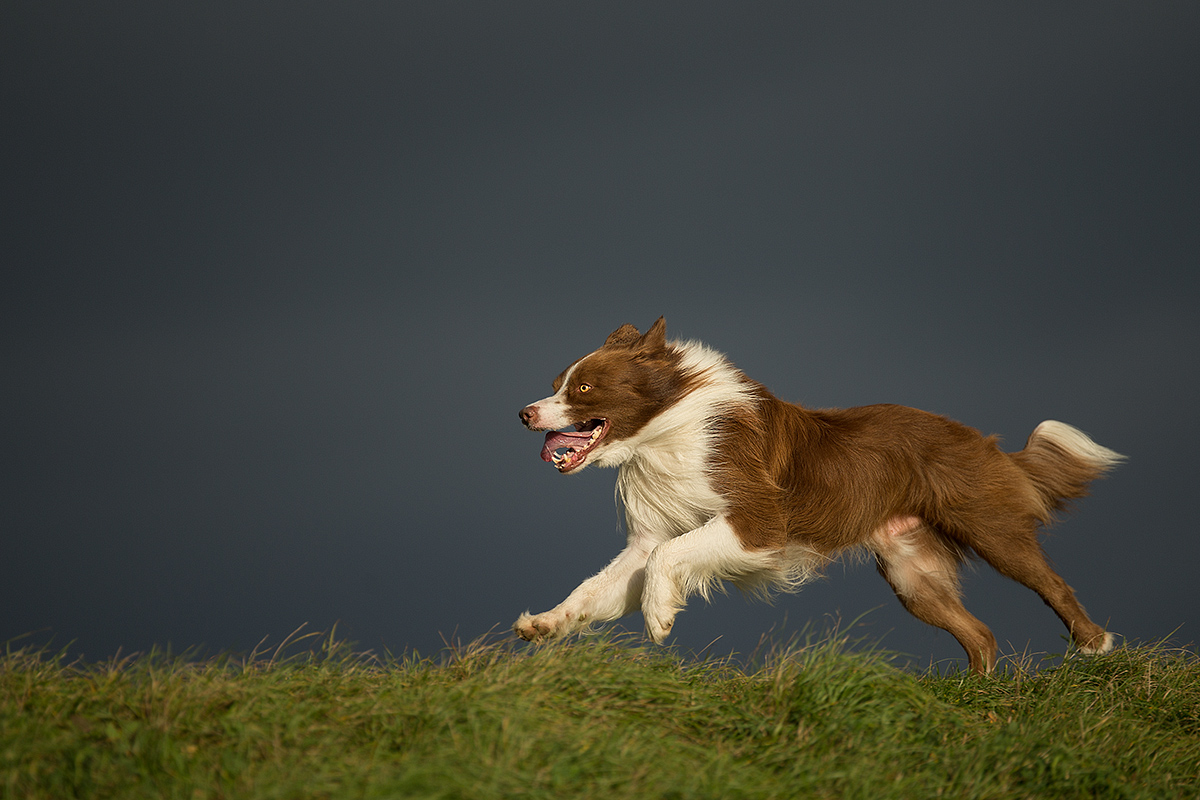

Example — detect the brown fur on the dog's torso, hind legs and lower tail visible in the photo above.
[714,384,1105,672]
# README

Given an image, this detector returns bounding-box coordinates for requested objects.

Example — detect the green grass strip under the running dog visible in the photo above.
[0,637,1200,800]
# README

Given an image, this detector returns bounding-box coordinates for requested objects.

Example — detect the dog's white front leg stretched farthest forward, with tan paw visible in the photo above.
[512,537,654,642]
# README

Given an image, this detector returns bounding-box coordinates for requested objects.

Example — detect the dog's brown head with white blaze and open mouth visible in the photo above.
[521,317,685,473]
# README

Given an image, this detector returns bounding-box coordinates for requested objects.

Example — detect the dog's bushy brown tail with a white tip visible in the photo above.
[1010,420,1126,523]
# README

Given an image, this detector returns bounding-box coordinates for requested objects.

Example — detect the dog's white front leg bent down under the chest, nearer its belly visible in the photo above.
[642,517,778,644]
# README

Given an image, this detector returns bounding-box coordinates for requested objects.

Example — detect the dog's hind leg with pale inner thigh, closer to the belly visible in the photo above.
[868,517,996,674]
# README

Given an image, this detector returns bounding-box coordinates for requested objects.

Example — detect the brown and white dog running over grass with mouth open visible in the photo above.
[512,318,1123,674]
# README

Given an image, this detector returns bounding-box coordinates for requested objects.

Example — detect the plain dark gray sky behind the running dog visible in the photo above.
[0,1,1200,664]
